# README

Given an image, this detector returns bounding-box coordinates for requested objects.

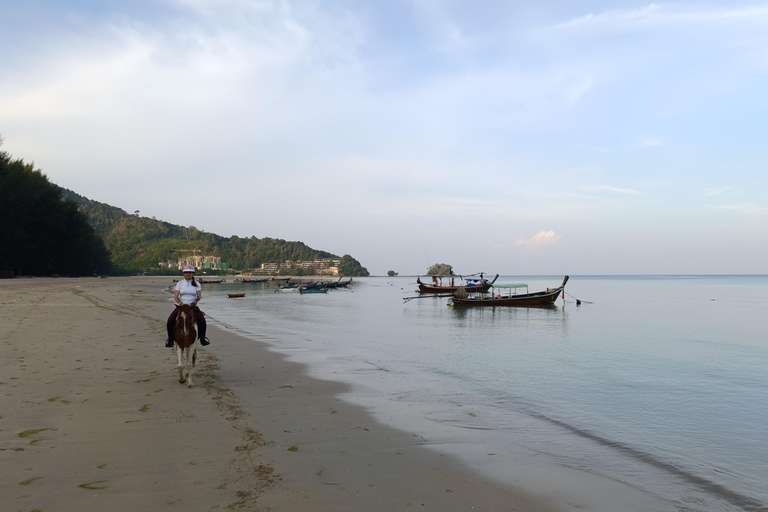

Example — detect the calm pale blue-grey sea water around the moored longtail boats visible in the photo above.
[204,276,768,511]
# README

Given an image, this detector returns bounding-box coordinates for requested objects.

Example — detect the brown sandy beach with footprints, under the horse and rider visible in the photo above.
[0,277,554,512]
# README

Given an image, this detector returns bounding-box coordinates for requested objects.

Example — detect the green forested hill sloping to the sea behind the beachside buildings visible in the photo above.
[62,189,368,276]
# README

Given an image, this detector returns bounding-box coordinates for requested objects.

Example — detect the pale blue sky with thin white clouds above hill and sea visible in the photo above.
[0,0,768,275]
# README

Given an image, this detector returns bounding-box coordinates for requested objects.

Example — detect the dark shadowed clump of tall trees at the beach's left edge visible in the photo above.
[0,146,113,277]
